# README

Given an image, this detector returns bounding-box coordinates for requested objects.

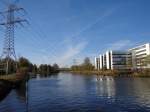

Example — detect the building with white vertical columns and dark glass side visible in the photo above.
[96,51,131,70]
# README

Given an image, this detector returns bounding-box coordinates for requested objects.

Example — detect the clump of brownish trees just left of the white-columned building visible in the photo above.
[71,57,94,71]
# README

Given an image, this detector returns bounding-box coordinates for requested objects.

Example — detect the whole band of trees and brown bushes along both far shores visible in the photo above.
[1,57,150,77]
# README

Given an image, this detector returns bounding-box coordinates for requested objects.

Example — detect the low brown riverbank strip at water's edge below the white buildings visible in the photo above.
[69,69,150,77]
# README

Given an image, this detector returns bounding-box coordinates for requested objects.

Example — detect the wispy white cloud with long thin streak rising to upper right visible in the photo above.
[49,9,115,66]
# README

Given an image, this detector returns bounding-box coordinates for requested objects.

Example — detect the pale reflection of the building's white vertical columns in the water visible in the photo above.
[96,76,116,98]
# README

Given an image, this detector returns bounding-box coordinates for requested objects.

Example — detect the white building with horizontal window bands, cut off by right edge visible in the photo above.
[129,43,150,68]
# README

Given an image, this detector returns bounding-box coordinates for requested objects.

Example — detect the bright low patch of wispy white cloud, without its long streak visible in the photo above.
[34,38,88,67]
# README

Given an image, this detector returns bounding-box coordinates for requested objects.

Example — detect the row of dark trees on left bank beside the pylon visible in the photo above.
[0,57,59,75]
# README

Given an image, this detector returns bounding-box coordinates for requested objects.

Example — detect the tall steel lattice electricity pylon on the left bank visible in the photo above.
[0,3,27,74]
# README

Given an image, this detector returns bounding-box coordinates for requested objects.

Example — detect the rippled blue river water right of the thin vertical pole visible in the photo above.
[27,73,150,112]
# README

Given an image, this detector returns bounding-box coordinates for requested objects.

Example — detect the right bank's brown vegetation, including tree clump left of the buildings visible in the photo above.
[68,57,150,77]
